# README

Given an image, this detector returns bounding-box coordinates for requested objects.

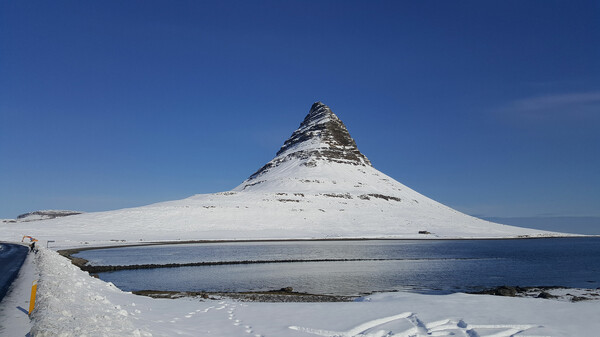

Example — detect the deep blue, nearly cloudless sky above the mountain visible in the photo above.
[0,0,600,228]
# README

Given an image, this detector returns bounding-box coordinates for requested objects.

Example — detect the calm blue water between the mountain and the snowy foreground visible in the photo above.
[76,238,600,295]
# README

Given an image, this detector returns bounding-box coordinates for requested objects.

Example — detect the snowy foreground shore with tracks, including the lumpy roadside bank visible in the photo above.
[0,245,600,337]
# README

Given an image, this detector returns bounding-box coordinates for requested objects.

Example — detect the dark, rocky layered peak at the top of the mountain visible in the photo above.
[249,102,372,179]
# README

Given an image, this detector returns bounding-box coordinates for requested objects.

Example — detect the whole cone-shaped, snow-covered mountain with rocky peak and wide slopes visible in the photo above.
[0,102,562,245]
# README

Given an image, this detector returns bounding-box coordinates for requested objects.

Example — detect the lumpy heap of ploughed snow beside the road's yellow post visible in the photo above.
[31,248,151,337]
